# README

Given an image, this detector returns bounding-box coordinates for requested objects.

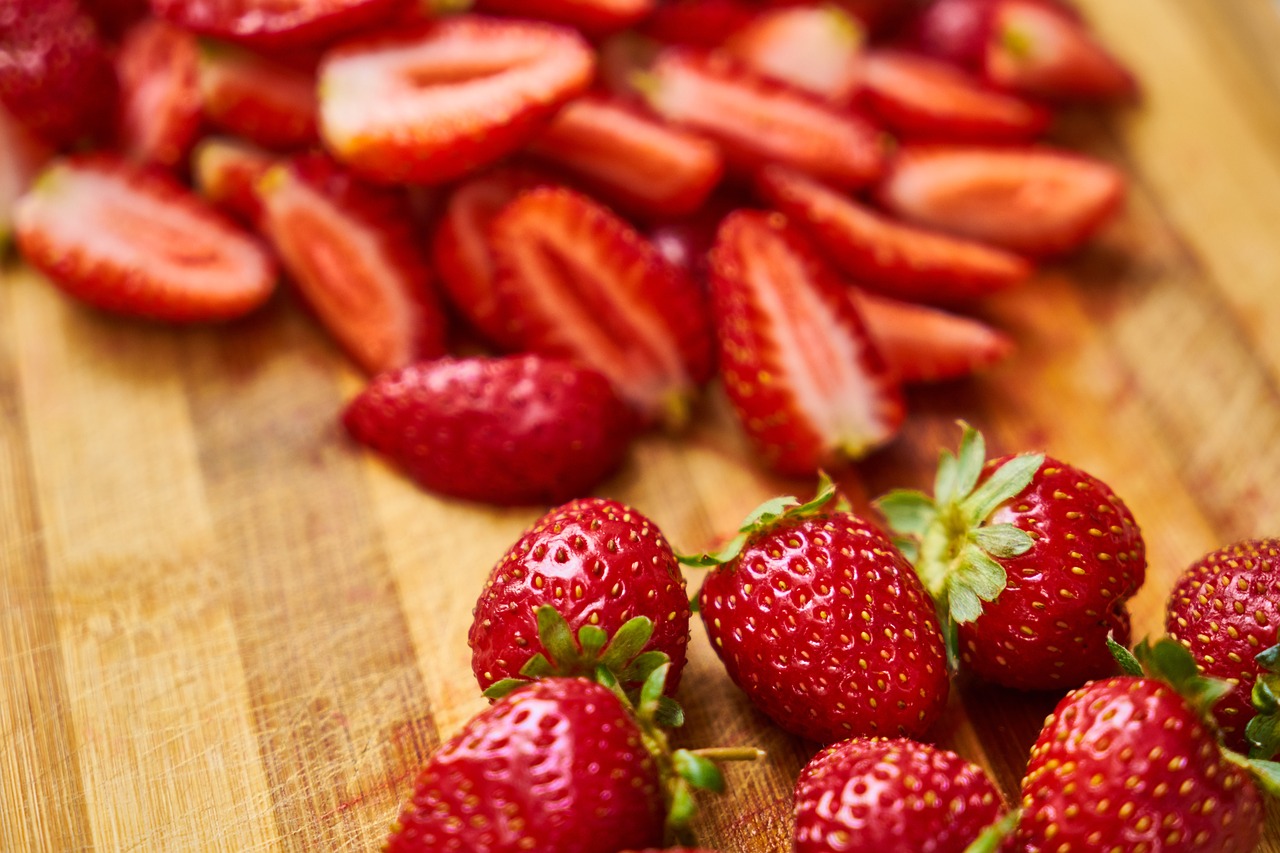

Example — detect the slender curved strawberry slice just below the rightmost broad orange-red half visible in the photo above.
[756,167,1032,302]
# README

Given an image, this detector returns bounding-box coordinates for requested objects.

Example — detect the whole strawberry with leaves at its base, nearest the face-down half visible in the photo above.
[467,494,689,697]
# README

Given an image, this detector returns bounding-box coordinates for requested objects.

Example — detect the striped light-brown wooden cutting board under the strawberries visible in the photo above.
[0,0,1280,853]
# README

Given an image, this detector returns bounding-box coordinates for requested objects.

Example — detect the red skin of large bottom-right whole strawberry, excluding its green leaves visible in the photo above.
[1016,678,1262,853]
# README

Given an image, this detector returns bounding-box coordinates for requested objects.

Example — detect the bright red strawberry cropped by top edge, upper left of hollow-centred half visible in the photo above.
[151,0,404,50]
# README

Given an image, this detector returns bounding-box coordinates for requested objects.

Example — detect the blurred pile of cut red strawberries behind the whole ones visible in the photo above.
[0,0,1137,503]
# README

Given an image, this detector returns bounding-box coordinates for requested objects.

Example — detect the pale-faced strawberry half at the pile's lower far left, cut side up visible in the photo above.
[15,154,275,323]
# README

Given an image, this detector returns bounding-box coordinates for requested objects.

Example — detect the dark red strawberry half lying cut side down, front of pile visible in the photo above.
[343,355,634,504]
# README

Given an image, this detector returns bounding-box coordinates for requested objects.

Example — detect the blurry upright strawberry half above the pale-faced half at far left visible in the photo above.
[115,18,200,169]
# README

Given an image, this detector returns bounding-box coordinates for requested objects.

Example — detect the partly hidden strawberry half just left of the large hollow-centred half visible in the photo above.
[200,41,319,150]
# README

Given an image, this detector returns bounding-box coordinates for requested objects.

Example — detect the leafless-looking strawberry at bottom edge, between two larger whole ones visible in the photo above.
[794,738,1005,853]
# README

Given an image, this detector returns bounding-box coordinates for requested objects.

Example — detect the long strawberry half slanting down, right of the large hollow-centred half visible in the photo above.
[643,47,884,187]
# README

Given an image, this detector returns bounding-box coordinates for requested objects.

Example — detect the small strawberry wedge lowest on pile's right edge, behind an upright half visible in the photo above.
[849,288,1014,382]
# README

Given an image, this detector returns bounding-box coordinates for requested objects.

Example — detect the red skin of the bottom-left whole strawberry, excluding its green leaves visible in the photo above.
[383,679,664,853]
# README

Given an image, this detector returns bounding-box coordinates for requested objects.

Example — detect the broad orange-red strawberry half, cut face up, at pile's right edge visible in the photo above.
[878,146,1125,255]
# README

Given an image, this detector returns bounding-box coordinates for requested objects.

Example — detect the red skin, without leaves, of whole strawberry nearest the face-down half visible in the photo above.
[467,498,690,693]
